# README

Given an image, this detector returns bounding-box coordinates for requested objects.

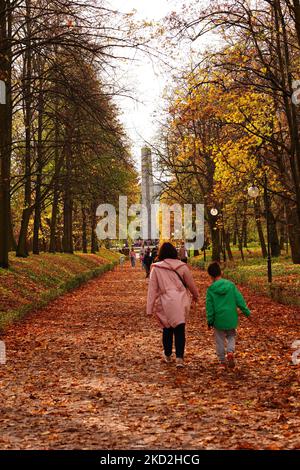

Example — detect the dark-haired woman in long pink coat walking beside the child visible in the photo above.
[147,243,199,367]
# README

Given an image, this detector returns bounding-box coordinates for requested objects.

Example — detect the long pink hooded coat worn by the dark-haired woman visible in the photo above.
[147,259,199,328]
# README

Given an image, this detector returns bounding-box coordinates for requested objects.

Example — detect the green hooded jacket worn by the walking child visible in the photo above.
[206,279,250,330]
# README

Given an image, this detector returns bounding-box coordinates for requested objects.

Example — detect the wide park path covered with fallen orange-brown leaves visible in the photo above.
[0,266,300,449]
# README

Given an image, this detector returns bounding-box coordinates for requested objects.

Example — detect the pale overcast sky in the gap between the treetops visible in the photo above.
[107,0,216,173]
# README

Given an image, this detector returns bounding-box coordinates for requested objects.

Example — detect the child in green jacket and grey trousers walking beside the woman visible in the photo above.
[206,262,250,368]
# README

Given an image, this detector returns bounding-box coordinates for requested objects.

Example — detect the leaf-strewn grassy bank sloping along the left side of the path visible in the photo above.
[0,248,119,330]
